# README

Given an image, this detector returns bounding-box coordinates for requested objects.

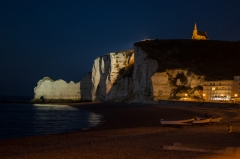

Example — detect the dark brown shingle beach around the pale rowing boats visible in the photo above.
[0,103,240,159]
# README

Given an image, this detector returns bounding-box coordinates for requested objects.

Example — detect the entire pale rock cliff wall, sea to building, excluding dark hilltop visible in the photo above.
[34,46,205,102]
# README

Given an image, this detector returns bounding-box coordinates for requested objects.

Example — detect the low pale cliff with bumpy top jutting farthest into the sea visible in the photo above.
[33,77,81,101]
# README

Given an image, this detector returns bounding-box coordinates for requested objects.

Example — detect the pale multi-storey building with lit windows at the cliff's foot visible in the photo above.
[203,76,240,101]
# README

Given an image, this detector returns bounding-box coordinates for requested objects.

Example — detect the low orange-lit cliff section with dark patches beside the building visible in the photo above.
[151,69,205,100]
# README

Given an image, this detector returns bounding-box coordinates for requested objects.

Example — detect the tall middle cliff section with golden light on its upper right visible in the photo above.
[91,50,134,101]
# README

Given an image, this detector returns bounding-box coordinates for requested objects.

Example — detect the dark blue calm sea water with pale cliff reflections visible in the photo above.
[0,103,101,139]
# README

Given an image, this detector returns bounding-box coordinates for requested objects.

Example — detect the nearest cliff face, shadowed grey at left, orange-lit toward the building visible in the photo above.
[133,46,205,102]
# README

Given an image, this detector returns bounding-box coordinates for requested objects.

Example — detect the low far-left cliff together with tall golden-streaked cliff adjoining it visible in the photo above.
[34,50,134,101]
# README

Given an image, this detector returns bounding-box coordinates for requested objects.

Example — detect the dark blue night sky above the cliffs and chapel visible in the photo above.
[0,0,240,96]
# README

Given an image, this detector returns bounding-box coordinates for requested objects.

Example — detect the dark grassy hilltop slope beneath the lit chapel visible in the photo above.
[134,39,240,79]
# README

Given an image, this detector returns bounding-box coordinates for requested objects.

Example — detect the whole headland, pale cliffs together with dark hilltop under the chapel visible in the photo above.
[34,40,240,102]
